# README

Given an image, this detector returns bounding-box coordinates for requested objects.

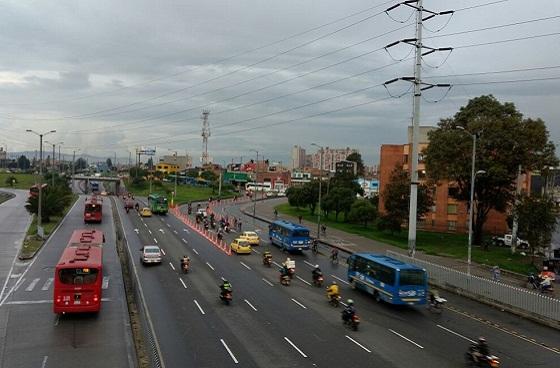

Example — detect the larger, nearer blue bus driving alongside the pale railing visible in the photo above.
[348,253,428,305]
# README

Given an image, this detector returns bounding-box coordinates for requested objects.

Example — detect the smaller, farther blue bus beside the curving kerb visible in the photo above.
[268,220,311,252]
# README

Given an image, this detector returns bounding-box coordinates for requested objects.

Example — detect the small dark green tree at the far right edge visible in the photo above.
[513,195,558,263]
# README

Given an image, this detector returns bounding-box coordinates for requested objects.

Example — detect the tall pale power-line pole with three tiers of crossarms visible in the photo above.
[385,0,453,257]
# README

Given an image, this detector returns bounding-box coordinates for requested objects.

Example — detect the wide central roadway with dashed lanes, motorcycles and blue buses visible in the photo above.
[118,201,560,367]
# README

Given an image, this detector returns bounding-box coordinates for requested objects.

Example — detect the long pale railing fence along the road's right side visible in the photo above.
[387,250,560,324]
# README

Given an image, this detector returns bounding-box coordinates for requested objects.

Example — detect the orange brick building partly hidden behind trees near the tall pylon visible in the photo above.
[379,126,516,234]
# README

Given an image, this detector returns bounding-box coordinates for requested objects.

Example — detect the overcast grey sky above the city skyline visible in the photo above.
[0,0,560,165]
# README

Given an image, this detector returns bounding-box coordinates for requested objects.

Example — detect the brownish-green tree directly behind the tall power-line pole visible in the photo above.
[378,165,433,234]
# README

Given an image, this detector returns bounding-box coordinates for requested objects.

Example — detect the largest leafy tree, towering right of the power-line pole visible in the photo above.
[423,95,558,244]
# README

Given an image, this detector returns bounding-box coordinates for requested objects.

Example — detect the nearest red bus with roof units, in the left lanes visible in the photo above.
[53,230,105,314]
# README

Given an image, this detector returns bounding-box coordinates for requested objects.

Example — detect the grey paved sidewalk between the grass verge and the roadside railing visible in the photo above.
[242,198,559,297]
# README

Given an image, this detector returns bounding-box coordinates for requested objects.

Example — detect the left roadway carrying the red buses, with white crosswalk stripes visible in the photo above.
[0,196,136,368]
